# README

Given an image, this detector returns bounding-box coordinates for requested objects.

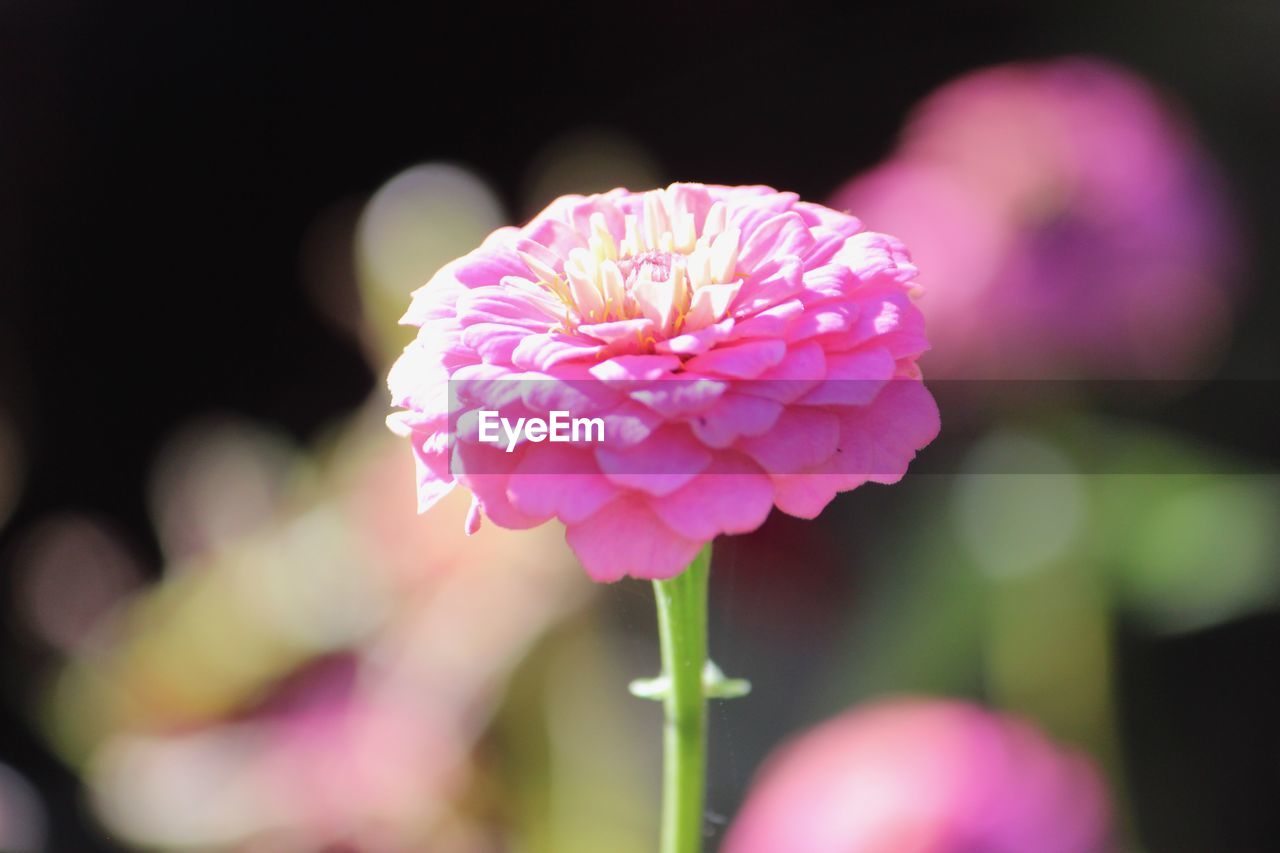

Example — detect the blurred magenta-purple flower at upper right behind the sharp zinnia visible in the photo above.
[833,59,1238,378]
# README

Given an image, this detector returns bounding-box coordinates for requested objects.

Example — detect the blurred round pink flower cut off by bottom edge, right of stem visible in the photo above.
[723,699,1108,853]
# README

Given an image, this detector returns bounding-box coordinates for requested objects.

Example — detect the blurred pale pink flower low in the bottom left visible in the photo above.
[90,650,470,850]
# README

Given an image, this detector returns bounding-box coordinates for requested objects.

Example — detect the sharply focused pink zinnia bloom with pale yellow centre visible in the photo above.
[388,183,938,580]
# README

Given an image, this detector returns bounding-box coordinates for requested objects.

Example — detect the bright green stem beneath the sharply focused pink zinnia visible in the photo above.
[653,543,712,853]
